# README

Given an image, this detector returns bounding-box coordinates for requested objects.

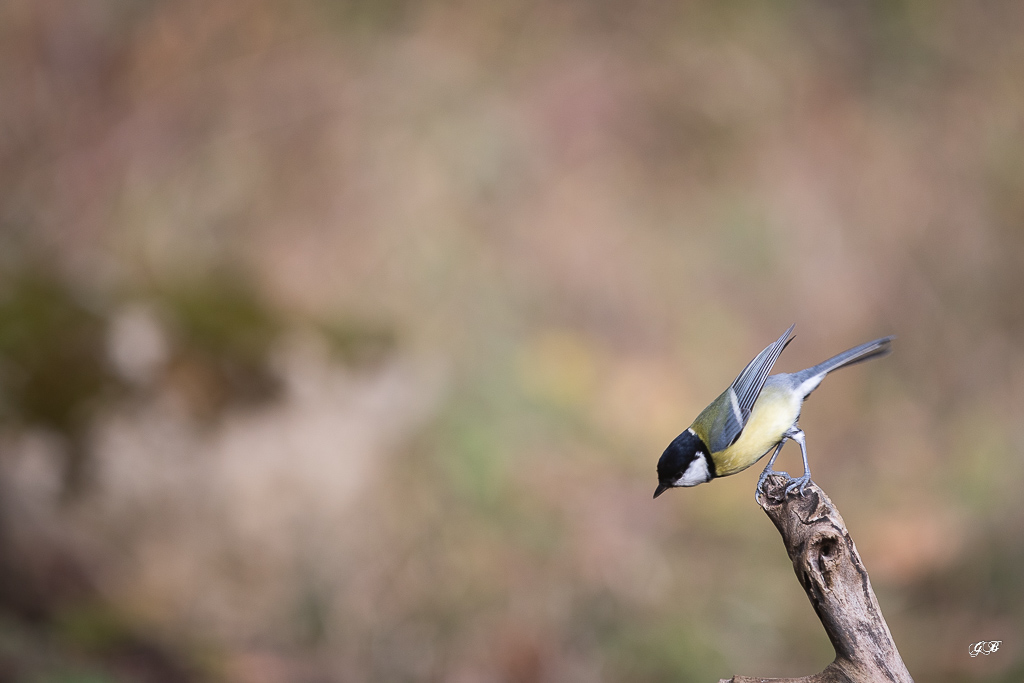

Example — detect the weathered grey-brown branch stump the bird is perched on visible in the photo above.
[719,475,913,683]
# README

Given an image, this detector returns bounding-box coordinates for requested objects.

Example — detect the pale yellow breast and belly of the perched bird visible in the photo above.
[712,385,803,476]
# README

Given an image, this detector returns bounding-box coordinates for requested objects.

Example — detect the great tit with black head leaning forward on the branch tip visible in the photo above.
[654,325,894,499]
